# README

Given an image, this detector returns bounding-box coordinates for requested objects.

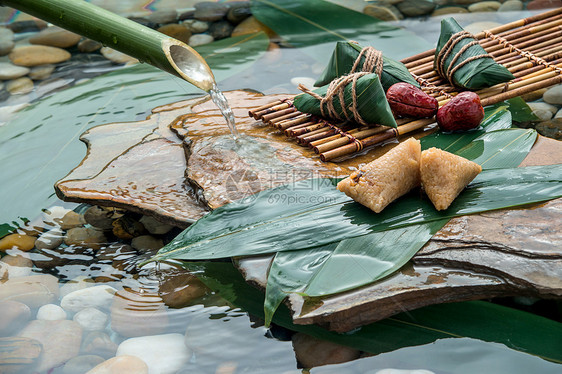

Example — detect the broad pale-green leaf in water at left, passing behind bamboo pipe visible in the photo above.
[0,33,269,223]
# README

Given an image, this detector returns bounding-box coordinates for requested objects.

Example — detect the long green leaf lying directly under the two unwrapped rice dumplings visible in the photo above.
[151,165,562,261]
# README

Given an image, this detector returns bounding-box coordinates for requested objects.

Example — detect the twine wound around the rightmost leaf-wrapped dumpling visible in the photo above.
[435,30,492,85]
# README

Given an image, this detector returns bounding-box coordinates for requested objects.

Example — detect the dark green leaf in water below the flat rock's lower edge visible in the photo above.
[188,262,562,367]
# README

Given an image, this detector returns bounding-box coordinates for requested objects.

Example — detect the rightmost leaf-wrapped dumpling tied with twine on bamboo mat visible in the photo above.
[434,18,515,90]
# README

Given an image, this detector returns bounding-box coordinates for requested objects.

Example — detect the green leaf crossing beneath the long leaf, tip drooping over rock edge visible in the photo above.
[264,106,536,323]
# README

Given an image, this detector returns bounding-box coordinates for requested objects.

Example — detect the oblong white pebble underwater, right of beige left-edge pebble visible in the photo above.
[61,285,117,313]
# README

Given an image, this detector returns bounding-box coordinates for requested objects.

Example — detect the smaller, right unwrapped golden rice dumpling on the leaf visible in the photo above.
[420,148,482,210]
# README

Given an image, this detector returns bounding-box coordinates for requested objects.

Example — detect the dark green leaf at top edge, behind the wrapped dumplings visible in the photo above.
[252,0,432,63]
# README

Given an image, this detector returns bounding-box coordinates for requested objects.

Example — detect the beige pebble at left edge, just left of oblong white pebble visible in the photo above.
[0,274,59,308]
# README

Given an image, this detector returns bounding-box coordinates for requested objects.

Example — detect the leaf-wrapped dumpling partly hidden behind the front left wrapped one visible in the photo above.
[314,42,419,91]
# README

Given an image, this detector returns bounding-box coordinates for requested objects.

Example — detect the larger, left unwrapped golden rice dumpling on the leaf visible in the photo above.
[337,138,421,213]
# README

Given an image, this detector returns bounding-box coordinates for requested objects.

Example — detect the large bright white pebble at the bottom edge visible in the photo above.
[117,334,191,374]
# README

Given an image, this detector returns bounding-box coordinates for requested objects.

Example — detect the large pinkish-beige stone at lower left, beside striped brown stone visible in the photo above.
[19,320,82,372]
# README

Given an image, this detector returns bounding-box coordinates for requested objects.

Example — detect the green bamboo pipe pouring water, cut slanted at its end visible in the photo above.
[0,0,215,92]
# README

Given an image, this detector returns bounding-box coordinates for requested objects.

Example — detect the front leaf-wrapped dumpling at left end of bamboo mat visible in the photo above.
[293,73,397,127]
